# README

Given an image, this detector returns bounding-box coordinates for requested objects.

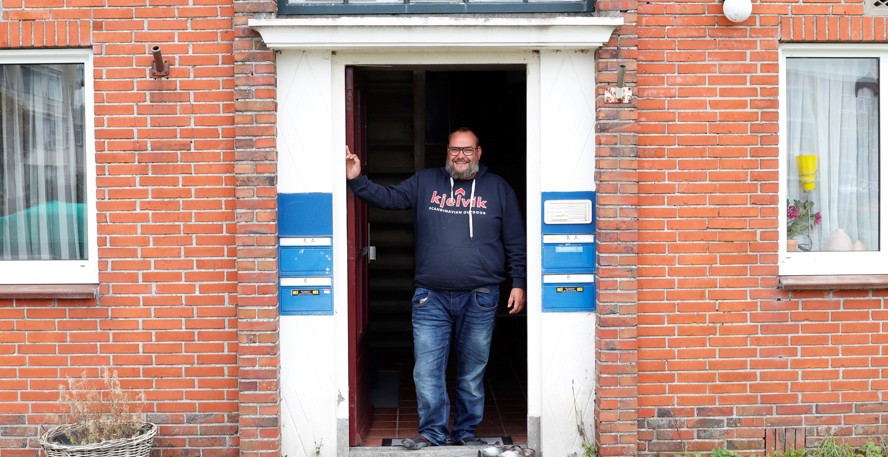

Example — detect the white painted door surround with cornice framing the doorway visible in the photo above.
[280,24,622,457]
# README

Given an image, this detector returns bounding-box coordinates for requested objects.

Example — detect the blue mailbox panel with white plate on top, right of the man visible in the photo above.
[542,192,595,312]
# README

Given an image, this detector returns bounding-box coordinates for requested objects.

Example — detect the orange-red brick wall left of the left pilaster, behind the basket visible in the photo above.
[0,0,242,457]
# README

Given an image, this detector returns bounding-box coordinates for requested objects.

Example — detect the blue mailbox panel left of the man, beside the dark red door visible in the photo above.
[278,194,333,316]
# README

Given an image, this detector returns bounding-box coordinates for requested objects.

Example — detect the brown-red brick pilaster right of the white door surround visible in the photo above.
[594,0,638,456]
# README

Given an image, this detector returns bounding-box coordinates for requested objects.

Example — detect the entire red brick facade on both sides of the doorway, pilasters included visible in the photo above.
[0,0,888,457]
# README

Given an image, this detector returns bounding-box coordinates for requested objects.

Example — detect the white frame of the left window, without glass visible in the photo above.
[0,49,99,285]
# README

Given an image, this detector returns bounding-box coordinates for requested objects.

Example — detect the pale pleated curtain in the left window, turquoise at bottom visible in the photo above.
[0,64,87,260]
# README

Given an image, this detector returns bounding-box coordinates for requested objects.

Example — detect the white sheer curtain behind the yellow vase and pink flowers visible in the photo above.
[786,58,879,251]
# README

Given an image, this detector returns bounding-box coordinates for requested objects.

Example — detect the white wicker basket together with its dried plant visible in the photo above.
[39,368,157,457]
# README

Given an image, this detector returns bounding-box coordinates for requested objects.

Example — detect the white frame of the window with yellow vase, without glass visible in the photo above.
[778,43,888,276]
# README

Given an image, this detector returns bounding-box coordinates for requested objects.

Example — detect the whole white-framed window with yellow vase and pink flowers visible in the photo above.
[780,44,888,275]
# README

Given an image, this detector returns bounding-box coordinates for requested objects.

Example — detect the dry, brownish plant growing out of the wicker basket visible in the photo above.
[61,368,145,445]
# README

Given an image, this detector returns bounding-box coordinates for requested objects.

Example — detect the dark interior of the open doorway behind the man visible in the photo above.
[350,65,527,446]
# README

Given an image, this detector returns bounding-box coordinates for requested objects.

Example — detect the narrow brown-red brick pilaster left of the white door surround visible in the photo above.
[234,0,281,457]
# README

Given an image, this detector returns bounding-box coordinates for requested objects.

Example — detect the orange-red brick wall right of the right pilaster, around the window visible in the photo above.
[638,1,888,455]
